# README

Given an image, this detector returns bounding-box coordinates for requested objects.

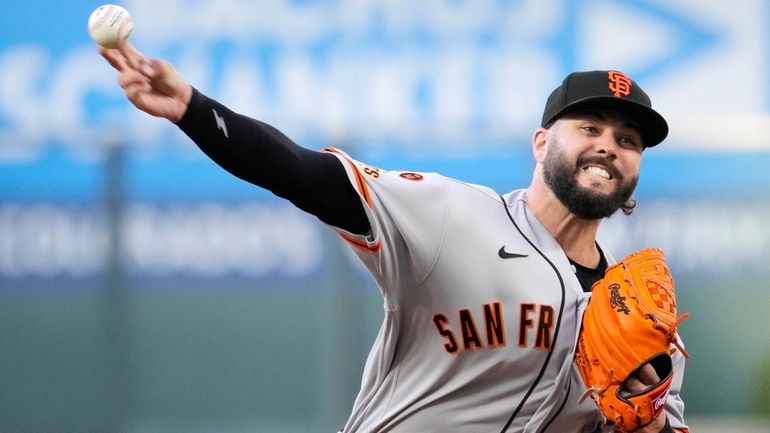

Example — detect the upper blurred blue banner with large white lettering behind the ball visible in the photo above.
[0,0,770,159]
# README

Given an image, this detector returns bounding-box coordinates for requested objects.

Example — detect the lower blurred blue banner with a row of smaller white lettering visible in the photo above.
[0,150,770,290]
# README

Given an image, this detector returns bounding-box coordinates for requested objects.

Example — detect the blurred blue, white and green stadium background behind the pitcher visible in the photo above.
[0,0,770,433]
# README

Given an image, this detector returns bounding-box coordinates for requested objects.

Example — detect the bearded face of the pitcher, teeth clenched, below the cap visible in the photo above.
[543,112,643,219]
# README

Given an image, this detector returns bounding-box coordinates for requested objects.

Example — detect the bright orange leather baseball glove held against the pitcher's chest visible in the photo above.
[575,248,688,432]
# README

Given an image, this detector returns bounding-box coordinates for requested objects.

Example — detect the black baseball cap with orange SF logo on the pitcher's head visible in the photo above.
[541,71,668,147]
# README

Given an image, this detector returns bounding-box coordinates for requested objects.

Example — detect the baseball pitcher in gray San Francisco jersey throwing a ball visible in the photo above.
[100,40,688,433]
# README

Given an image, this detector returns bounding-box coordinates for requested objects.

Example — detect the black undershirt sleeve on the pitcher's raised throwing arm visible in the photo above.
[177,89,370,234]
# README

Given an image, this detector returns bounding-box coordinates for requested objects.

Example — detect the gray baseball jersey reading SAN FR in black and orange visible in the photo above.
[320,149,686,433]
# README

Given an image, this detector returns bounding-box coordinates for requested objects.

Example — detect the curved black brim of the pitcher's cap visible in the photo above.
[551,96,668,147]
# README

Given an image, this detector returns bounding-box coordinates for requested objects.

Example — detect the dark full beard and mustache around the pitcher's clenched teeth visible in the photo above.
[543,139,639,220]
